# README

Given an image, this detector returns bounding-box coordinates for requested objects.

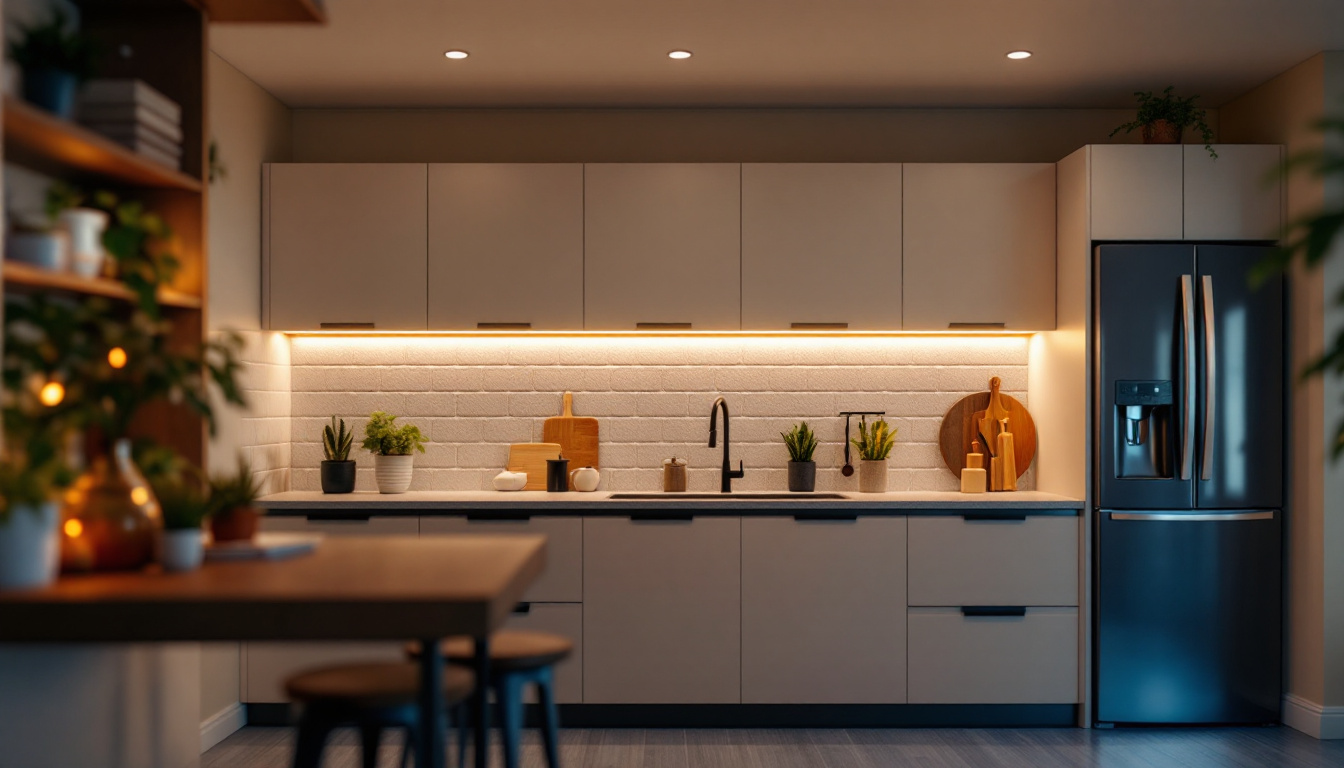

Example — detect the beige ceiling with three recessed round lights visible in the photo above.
[211,0,1344,108]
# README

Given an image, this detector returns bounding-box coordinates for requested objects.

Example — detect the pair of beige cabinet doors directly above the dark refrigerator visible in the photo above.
[1089,144,1284,241]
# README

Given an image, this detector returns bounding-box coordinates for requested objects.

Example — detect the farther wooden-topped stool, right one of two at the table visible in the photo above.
[406,629,574,768]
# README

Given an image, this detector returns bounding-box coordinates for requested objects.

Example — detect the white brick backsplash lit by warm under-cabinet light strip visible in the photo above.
[288,336,1034,491]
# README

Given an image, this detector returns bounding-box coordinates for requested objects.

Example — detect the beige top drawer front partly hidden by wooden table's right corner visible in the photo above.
[419,516,583,603]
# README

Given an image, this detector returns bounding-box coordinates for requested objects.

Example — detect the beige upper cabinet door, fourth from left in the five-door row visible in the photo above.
[742,163,900,331]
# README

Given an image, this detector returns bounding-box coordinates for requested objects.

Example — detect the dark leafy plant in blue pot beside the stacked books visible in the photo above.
[9,8,98,120]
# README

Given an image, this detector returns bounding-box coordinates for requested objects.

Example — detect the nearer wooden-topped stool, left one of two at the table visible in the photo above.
[285,662,474,768]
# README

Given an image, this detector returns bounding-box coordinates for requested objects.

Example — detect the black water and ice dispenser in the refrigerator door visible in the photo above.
[1114,381,1176,479]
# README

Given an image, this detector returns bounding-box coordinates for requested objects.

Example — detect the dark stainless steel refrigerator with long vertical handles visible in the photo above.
[1093,245,1286,725]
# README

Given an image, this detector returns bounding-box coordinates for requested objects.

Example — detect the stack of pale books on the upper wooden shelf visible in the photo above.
[78,79,181,169]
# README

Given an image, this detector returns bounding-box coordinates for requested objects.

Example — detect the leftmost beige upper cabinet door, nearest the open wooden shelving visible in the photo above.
[262,163,426,331]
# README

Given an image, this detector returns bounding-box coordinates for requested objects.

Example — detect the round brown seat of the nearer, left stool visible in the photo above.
[285,662,474,709]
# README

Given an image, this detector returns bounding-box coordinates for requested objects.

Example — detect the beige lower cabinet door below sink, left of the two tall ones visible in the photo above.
[583,518,742,703]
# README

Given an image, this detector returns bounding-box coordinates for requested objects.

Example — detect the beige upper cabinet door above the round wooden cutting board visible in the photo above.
[903,163,1055,331]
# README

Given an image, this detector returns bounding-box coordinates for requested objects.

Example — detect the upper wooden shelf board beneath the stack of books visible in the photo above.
[4,97,202,192]
